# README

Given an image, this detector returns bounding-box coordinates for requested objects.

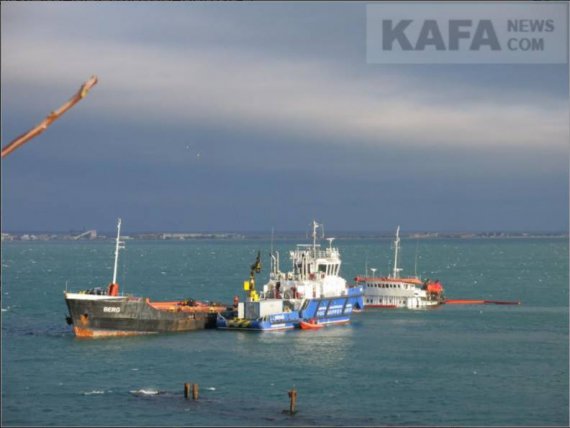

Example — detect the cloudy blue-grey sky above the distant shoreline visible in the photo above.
[1,2,570,233]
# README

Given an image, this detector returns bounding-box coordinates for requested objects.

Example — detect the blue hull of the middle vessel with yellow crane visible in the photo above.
[216,286,364,331]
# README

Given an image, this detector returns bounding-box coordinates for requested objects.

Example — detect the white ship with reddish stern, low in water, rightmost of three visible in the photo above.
[354,226,445,309]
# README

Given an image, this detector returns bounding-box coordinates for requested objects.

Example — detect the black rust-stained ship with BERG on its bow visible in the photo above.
[64,219,231,338]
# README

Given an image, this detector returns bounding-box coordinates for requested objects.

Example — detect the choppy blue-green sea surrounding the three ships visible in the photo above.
[1,239,569,426]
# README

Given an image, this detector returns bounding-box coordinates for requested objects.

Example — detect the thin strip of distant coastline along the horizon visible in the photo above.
[2,230,570,242]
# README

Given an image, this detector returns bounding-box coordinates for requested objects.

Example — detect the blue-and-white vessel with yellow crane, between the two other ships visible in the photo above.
[217,221,364,331]
